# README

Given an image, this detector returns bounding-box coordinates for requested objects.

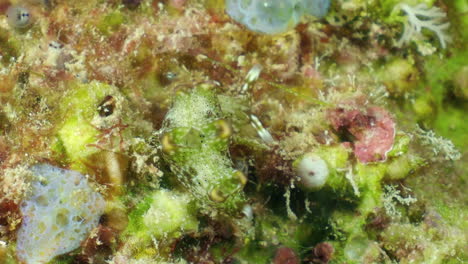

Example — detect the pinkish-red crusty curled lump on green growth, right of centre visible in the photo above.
[329,106,395,163]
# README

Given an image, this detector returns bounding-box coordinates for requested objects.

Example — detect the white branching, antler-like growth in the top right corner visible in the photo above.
[395,4,450,49]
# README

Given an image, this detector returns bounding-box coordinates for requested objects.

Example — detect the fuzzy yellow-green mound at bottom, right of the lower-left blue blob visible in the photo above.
[122,189,199,263]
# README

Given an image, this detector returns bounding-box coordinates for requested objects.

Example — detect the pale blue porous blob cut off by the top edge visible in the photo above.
[226,0,330,34]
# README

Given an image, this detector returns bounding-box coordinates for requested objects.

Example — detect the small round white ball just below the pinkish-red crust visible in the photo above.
[296,154,329,189]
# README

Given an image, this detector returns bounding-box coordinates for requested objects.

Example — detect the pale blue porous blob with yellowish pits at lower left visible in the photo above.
[16,164,105,264]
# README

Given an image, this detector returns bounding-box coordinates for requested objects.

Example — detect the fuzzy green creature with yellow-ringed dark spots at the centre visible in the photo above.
[161,84,247,212]
